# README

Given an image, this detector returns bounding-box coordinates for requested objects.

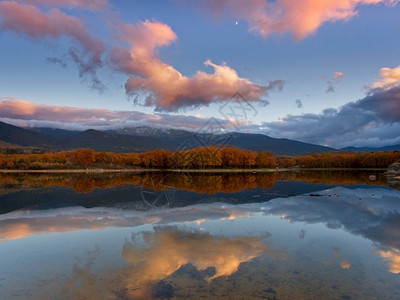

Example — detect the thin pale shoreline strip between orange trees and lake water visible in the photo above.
[0,168,388,173]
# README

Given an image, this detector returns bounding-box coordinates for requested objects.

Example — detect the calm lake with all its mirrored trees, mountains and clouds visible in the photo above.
[0,170,400,299]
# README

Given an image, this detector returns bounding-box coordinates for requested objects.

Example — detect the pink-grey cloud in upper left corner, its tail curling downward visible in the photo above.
[0,1,104,88]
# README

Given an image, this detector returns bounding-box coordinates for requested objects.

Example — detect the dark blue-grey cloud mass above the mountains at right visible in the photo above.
[262,87,400,147]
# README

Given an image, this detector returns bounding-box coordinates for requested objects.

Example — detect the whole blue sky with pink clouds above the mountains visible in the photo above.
[0,0,400,148]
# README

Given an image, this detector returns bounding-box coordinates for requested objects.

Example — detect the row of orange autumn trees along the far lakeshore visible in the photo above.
[0,147,400,170]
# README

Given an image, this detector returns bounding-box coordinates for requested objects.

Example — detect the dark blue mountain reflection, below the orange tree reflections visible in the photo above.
[0,181,329,214]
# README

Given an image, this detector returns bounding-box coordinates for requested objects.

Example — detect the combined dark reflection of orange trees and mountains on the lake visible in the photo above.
[0,171,386,214]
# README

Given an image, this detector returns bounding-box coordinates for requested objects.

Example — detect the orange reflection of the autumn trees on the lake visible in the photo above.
[0,171,387,194]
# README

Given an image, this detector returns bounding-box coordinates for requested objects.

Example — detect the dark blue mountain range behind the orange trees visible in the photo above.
[0,122,400,155]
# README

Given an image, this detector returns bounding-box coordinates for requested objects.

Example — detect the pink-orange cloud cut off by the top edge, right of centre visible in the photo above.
[198,0,398,39]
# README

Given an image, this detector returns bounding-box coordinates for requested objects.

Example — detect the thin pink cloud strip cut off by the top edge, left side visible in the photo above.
[18,0,109,11]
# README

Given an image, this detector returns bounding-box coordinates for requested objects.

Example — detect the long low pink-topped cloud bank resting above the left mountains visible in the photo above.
[0,97,238,130]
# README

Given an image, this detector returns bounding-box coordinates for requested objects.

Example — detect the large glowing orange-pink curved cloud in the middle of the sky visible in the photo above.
[111,21,274,111]
